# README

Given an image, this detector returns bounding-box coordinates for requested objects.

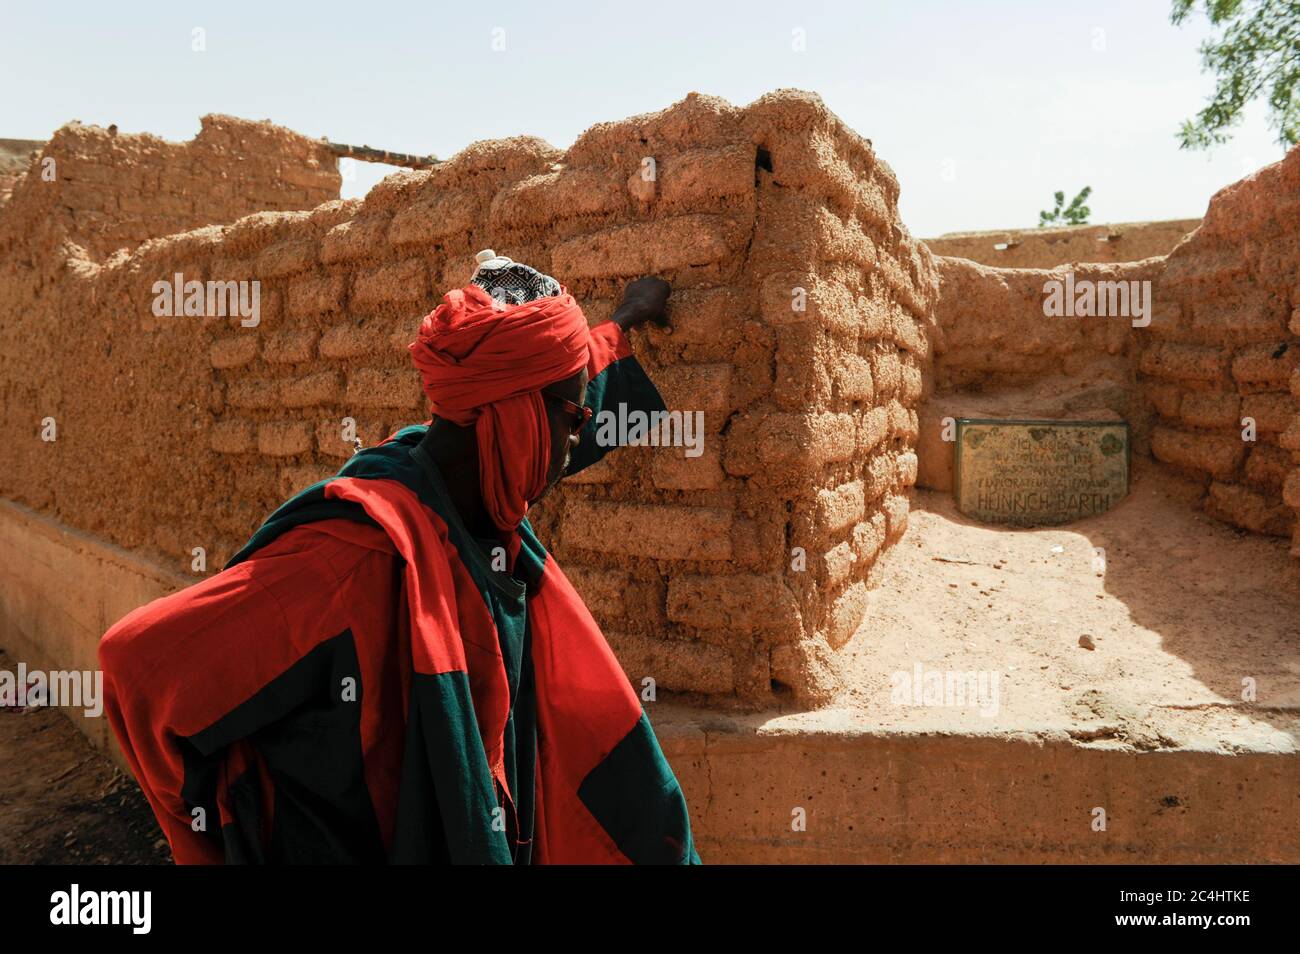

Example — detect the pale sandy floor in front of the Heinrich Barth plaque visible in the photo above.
[835,472,1300,751]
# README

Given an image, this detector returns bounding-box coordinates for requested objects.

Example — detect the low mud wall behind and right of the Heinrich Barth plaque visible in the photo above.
[919,149,1300,555]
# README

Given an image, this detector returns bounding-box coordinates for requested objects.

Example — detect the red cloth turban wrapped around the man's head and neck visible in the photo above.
[410,285,590,530]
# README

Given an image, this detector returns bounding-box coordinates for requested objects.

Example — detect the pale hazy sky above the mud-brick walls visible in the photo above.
[0,0,1282,237]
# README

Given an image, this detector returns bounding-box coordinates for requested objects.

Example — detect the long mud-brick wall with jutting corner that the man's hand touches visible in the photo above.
[0,92,935,701]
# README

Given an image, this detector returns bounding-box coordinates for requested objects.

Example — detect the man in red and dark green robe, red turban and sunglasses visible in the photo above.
[100,251,699,864]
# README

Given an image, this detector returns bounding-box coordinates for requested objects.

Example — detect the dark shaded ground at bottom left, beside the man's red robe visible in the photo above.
[0,651,172,864]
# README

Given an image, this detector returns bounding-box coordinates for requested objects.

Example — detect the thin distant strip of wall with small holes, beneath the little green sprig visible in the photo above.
[924,218,1200,268]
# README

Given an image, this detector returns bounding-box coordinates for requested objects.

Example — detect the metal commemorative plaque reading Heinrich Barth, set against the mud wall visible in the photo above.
[956,417,1128,526]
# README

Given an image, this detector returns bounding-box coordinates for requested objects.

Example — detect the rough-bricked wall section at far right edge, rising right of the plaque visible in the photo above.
[1139,148,1300,540]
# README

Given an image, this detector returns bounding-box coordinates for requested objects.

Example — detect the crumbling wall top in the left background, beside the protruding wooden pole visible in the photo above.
[0,114,342,260]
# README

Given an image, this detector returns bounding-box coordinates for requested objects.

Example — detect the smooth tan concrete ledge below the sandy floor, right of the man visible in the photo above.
[650,703,1300,864]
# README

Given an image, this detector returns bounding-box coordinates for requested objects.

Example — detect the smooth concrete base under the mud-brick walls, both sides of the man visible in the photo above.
[0,502,1300,863]
